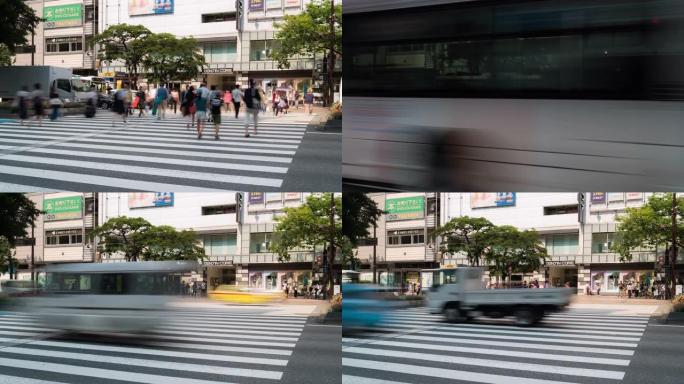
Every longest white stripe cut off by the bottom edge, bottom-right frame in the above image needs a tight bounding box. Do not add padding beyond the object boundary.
[342,357,575,384]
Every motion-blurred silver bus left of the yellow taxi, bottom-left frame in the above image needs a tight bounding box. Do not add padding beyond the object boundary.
[22,261,201,332]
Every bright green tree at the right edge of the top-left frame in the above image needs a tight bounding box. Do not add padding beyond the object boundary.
[271,0,342,105]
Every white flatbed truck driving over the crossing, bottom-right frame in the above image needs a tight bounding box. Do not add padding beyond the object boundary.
[427,267,572,326]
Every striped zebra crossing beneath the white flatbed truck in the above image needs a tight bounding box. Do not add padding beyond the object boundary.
[342,308,649,384]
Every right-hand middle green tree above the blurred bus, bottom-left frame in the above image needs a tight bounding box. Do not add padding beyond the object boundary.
[141,225,206,261]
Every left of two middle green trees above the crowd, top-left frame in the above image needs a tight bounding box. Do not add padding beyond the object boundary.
[93,24,152,89]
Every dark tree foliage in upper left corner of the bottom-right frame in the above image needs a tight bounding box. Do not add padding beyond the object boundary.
[342,191,385,247]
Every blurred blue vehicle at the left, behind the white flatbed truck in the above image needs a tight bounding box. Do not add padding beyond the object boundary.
[342,283,402,330]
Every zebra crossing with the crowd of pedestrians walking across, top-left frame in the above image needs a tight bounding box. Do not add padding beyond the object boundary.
[0,111,307,191]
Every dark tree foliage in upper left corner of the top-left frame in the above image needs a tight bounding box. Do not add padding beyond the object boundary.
[0,0,42,53]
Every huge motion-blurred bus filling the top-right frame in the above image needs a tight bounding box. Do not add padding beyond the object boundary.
[342,0,684,191]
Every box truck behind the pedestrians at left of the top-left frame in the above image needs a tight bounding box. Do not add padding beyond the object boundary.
[0,66,80,101]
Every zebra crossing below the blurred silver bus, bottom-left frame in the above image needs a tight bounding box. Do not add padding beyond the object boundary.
[0,309,307,384]
